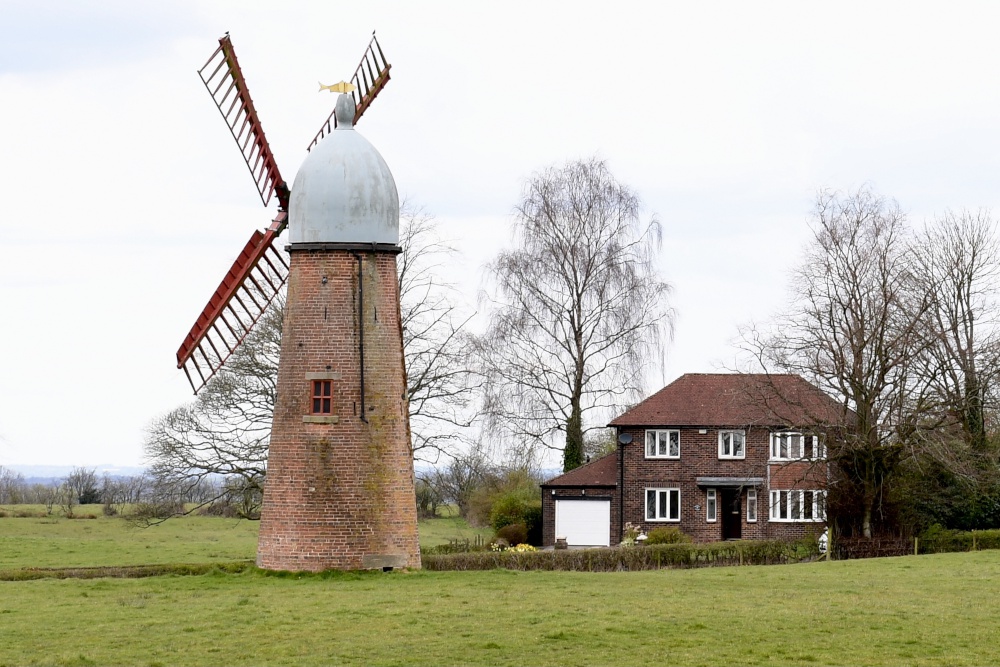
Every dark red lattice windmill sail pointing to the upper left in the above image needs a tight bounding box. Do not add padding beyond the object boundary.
[198,34,288,211]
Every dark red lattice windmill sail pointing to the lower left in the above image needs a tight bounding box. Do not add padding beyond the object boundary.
[177,213,288,393]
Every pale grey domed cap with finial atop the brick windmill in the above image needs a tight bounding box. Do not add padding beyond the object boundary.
[288,94,399,245]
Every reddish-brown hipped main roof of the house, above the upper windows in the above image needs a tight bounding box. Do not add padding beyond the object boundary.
[610,373,849,426]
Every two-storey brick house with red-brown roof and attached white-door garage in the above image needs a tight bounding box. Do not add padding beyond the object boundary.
[541,373,846,546]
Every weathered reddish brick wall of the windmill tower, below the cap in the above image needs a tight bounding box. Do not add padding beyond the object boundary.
[257,248,420,571]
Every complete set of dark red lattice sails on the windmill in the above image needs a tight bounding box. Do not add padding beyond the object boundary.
[177,33,391,393]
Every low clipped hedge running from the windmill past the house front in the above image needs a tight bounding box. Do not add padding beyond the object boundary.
[422,540,819,572]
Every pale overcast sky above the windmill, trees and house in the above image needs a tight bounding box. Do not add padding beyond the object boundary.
[0,0,1000,465]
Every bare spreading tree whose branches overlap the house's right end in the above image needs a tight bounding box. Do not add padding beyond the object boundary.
[743,188,930,537]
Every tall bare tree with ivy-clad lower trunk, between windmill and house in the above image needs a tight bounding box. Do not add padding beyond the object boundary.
[476,158,673,470]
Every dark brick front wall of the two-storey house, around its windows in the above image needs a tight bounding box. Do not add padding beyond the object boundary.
[620,427,826,542]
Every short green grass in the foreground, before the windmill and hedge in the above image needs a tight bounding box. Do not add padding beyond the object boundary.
[0,551,1000,665]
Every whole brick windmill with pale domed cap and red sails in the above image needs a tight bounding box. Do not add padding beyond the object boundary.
[178,36,420,571]
